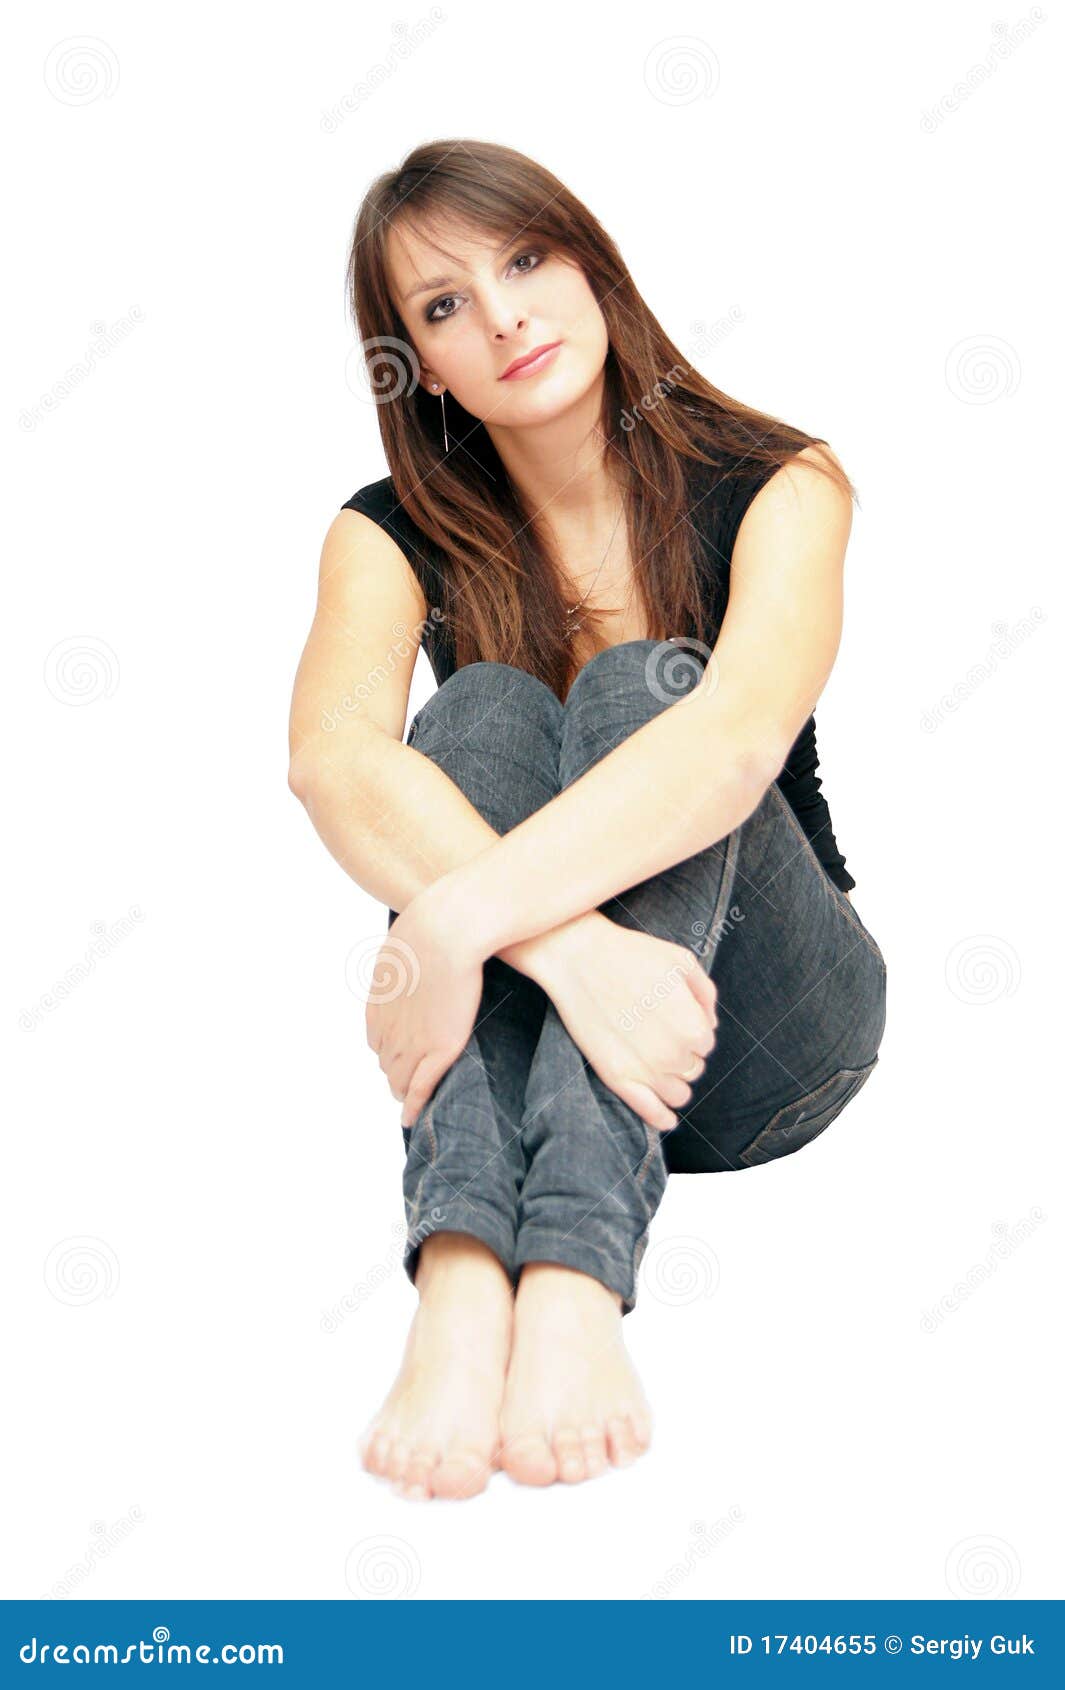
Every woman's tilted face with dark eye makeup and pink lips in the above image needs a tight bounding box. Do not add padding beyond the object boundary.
[387,225,609,428]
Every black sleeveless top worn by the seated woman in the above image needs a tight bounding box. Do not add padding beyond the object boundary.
[341,460,857,892]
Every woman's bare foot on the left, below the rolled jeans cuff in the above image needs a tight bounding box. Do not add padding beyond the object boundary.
[358,1232,514,1499]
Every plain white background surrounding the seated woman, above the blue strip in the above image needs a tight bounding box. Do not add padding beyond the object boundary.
[0,0,1062,1600]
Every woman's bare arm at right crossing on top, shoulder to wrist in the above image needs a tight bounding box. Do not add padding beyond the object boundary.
[419,448,850,962]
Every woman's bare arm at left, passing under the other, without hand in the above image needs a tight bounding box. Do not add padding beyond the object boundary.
[289,510,605,979]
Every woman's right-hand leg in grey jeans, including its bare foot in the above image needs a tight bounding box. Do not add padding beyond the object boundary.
[502,641,884,1484]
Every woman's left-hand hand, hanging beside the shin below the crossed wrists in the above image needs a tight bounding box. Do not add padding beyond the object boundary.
[367,887,483,1127]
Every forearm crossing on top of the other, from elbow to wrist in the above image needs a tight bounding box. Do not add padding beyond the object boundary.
[440,696,776,957]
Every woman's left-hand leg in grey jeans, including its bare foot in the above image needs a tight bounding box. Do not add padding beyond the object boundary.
[362,662,563,1497]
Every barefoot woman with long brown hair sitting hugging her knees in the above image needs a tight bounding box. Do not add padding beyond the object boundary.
[291,142,886,1497]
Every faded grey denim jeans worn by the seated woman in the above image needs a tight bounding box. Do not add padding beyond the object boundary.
[389,641,886,1313]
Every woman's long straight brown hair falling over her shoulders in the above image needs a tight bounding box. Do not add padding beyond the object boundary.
[347,140,855,696]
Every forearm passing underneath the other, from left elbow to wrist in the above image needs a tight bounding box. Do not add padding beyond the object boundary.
[289,728,604,979]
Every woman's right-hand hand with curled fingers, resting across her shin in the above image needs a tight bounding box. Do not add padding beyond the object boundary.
[527,911,717,1132]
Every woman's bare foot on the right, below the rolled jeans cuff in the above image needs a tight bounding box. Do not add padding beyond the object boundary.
[500,1262,651,1484]
